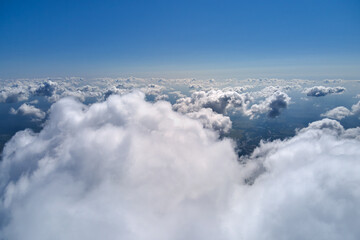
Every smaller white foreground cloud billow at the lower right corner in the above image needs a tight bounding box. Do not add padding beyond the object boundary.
[233,119,360,240]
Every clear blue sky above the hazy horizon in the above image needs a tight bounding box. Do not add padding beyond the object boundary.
[0,0,360,79]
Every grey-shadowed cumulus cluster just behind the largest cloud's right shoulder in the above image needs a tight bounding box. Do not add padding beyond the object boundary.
[173,86,291,129]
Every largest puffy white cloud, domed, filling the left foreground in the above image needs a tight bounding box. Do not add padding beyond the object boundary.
[0,93,238,240]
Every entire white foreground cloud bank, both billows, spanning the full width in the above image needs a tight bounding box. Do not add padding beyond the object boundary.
[0,92,360,240]
